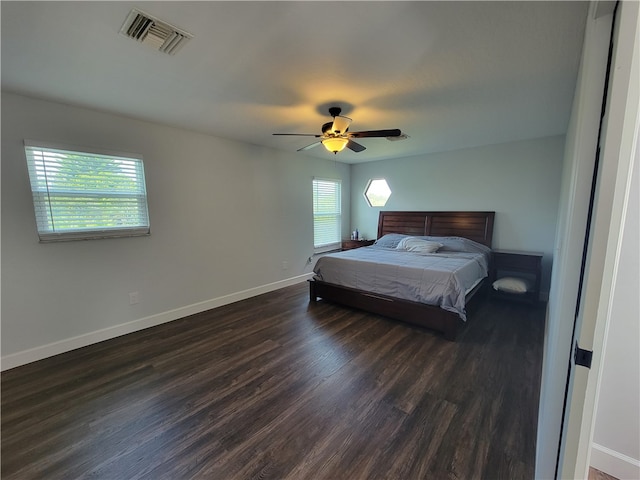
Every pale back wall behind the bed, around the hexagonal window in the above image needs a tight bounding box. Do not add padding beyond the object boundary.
[351,136,564,293]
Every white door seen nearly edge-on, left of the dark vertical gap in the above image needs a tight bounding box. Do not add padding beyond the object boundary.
[535,2,613,480]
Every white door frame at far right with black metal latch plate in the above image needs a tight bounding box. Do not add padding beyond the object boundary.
[558,2,640,479]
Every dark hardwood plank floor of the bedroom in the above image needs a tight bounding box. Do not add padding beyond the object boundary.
[1,283,544,480]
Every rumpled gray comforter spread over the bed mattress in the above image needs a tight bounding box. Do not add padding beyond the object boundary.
[314,245,488,320]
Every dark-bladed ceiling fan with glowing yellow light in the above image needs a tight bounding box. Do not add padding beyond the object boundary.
[274,107,402,154]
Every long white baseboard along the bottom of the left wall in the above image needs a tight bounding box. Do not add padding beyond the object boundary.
[0,273,313,371]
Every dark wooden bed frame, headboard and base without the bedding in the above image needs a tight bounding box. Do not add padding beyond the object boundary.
[309,212,495,341]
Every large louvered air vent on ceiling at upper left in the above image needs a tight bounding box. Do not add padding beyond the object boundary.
[120,8,193,55]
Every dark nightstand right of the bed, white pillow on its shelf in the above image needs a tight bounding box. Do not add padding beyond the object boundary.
[489,250,544,304]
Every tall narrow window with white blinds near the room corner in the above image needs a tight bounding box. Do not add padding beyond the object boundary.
[313,178,342,253]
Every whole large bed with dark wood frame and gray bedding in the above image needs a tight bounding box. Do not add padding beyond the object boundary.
[309,211,495,340]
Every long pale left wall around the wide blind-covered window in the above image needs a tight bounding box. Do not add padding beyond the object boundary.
[1,93,350,369]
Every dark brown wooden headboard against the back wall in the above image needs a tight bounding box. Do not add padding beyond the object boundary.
[378,212,495,247]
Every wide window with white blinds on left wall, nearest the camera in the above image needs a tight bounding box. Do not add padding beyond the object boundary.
[25,141,150,242]
